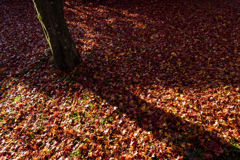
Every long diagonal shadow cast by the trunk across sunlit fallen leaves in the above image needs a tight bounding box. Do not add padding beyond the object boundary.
[67,47,239,158]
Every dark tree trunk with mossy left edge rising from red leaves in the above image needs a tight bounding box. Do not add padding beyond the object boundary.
[33,0,81,70]
